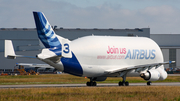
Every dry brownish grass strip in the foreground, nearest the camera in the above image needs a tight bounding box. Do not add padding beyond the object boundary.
[0,86,180,101]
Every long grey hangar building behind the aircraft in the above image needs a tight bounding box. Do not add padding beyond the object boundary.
[0,28,180,71]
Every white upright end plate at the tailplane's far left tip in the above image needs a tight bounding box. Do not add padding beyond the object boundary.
[4,40,16,59]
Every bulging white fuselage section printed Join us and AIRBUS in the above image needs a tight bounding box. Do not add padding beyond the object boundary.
[51,36,164,77]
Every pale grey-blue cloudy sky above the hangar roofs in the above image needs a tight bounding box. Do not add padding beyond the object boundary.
[0,0,180,34]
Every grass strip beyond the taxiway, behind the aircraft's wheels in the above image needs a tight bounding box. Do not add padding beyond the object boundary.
[0,74,180,85]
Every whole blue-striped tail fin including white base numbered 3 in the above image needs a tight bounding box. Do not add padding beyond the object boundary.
[33,12,72,59]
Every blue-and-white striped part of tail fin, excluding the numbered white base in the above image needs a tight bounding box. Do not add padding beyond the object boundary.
[33,12,62,49]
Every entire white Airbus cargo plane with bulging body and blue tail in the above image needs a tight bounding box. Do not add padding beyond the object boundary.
[5,12,175,86]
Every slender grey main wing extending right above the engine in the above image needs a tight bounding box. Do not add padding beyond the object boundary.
[105,61,175,76]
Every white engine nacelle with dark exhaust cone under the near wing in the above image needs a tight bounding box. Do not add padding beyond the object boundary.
[140,70,160,81]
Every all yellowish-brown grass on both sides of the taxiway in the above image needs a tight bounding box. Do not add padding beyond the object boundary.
[0,74,180,101]
